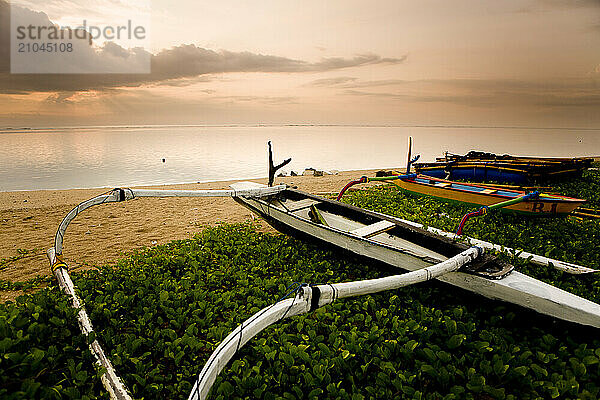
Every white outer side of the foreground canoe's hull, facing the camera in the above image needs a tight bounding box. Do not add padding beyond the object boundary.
[236,184,600,328]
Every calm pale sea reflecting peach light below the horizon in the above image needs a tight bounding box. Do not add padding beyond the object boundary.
[0,125,600,191]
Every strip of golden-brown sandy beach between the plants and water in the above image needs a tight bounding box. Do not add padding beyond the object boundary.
[0,167,384,301]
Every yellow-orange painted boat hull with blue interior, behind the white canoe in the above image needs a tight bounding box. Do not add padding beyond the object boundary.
[390,174,585,216]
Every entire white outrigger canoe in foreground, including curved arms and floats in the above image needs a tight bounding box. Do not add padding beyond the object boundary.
[48,145,600,400]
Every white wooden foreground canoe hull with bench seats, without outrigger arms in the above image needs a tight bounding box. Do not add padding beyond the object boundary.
[231,182,600,328]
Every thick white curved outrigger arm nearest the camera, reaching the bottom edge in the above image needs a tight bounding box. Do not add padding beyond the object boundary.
[188,246,484,400]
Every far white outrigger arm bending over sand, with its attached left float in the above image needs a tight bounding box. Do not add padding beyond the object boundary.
[47,185,286,400]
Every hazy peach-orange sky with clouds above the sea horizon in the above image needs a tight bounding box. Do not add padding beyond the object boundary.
[0,0,600,128]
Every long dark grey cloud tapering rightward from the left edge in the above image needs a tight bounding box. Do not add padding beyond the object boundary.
[0,0,406,93]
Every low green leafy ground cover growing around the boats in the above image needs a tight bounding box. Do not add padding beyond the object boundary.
[0,171,600,399]
